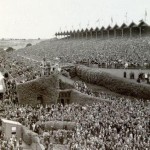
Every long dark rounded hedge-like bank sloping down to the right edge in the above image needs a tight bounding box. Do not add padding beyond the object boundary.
[76,65,150,99]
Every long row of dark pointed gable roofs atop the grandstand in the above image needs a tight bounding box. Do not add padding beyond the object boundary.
[55,20,150,39]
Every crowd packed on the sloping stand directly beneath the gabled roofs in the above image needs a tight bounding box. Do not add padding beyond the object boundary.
[14,37,150,68]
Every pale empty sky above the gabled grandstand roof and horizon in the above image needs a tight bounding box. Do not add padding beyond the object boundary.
[0,0,150,39]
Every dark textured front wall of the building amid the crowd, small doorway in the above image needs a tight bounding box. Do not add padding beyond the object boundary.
[17,75,59,105]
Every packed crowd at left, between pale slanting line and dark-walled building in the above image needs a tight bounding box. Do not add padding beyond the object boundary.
[1,57,41,83]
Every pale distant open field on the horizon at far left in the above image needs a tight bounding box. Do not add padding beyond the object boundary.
[0,39,42,50]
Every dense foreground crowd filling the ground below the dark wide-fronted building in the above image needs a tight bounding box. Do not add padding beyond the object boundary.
[0,98,150,150]
